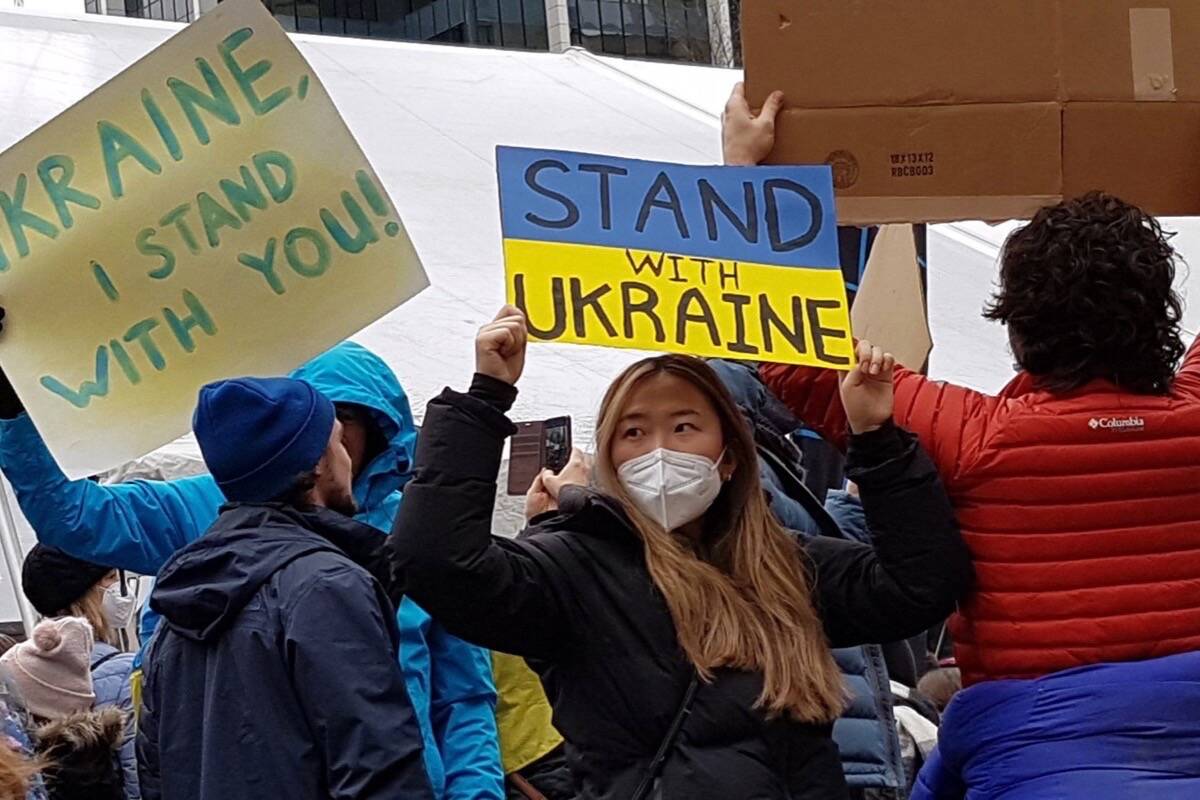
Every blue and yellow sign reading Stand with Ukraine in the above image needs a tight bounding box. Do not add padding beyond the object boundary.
[497,148,853,369]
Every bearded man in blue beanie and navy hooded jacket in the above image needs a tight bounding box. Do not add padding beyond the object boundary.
[138,378,433,800]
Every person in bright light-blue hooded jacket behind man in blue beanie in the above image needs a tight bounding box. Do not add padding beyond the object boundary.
[0,343,504,800]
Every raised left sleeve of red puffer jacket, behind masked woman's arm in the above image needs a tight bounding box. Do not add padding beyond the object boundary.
[761,363,1003,483]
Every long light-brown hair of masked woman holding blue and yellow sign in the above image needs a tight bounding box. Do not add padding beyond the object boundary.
[596,355,846,722]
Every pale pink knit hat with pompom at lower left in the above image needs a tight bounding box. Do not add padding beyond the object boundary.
[0,616,96,720]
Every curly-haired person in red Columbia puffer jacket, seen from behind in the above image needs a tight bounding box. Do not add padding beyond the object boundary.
[725,82,1200,685]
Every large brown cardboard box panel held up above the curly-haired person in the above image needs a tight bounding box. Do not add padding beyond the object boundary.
[742,0,1200,224]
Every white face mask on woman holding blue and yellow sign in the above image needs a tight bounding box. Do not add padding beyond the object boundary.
[617,447,724,530]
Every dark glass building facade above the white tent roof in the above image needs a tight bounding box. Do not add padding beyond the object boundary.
[85,0,713,64]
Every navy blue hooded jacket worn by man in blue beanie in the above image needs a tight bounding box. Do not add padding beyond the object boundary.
[138,504,433,800]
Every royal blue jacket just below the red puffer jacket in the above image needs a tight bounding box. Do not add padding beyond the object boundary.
[912,652,1200,800]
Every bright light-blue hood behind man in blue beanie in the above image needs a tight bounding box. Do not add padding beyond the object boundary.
[292,342,416,531]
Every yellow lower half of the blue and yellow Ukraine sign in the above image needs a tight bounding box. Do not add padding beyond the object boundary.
[504,239,853,369]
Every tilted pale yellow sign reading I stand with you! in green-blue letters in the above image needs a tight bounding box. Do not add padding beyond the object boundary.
[0,0,427,477]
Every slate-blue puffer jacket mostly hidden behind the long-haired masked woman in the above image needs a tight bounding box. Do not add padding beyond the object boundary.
[709,361,906,789]
